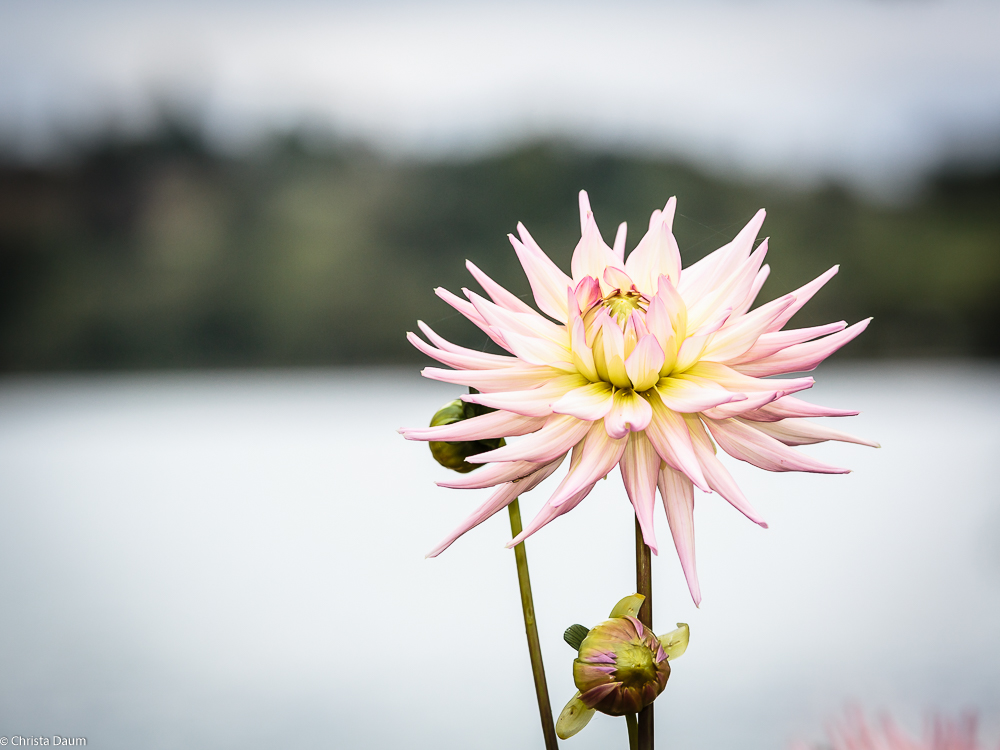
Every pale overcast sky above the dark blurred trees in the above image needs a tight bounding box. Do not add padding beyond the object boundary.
[0,0,1000,191]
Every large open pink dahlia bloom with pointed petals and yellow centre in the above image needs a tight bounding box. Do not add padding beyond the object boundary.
[401,192,876,603]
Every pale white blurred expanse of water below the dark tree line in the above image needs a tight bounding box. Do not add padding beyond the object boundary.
[0,362,1000,750]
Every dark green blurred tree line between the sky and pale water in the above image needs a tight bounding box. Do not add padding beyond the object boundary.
[0,126,1000,372]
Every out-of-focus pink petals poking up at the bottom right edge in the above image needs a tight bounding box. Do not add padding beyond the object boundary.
[795,711,984,750]
